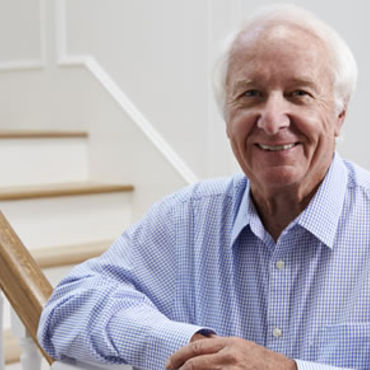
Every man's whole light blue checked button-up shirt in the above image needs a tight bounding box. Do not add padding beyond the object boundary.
[39,155,370,370]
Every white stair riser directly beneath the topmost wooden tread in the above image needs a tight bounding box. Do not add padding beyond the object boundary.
[0,138,88,187]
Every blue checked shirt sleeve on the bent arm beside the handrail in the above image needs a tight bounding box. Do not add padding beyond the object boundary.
[38,195,212,369]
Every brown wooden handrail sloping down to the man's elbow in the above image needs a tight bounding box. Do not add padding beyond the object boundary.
[0,211,54,364]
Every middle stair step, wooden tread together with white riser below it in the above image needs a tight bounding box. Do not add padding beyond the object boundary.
[0,183,133,250]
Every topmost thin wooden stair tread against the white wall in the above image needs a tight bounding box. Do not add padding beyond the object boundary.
[0,130,88,139]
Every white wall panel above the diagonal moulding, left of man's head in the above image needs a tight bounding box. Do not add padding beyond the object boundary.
[60,0,235,177]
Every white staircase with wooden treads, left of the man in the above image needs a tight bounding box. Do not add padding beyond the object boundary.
[0,130,134,363]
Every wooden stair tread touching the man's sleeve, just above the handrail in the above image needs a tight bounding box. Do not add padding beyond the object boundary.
[31,240,113,268]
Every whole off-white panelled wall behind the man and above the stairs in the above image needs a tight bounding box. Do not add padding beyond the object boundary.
[0,0,370,202]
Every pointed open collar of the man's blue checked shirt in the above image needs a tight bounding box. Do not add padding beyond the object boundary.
[231,153,348,248]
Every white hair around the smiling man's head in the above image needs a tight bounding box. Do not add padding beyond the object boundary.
[213,4,358,117]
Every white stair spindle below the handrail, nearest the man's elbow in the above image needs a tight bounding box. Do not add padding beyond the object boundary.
[11,310,41,370]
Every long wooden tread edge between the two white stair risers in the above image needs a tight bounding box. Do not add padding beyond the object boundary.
[0,182,134,201]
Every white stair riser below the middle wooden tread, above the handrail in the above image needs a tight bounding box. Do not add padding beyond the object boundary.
[0,193,132,250]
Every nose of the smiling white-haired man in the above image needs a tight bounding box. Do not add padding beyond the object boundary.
[257,92,290,135]
